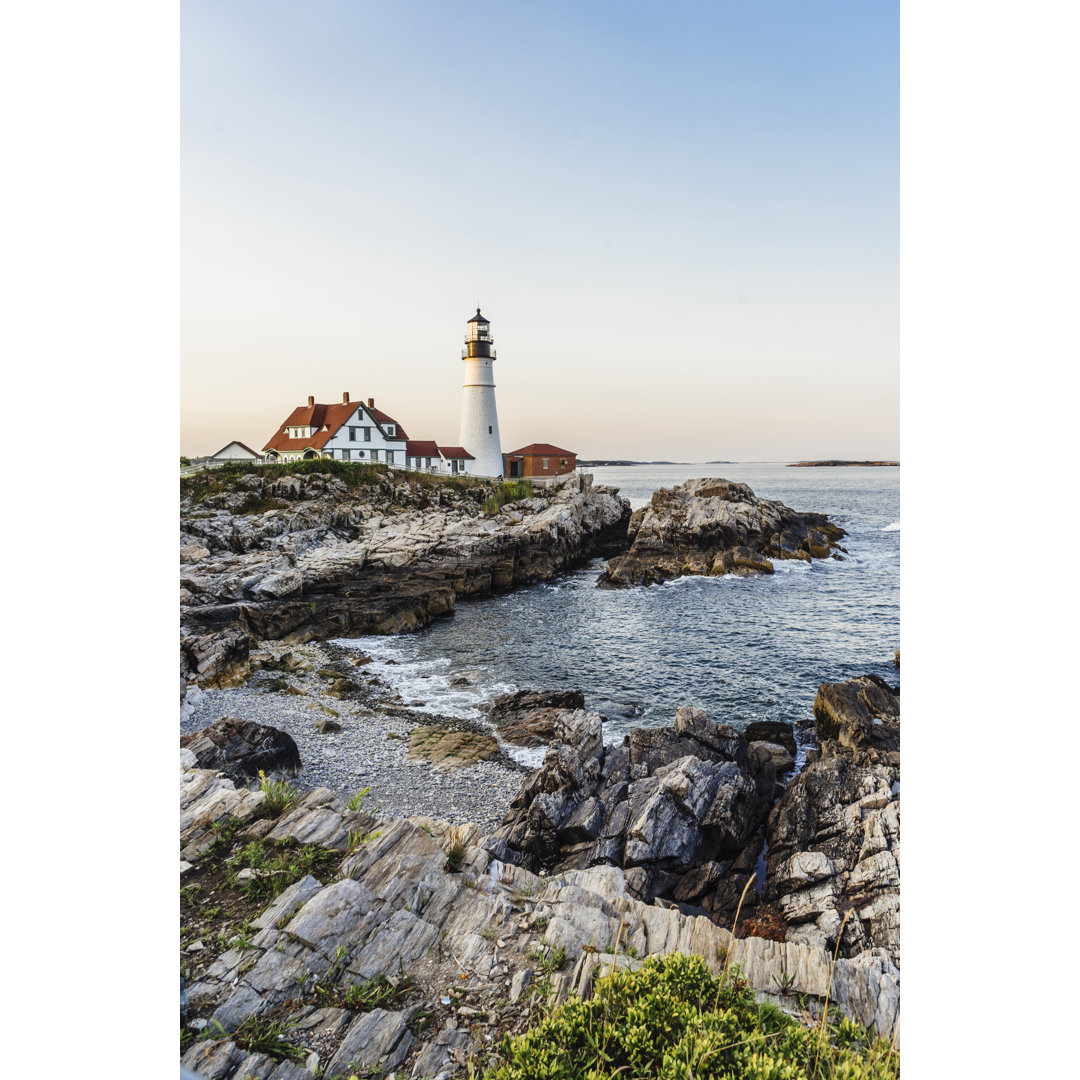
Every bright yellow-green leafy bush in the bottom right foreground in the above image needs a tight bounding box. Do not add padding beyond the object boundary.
[484,955,900,1080]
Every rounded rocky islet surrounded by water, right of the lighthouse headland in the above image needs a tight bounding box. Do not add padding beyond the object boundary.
[599,480,843,588]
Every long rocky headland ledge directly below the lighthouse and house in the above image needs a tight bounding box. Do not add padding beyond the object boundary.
[180,474,630,685]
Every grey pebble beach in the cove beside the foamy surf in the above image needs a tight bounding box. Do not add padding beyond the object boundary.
[180,643,527,829]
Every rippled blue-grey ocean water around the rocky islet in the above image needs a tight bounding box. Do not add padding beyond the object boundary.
[337,462,900,765]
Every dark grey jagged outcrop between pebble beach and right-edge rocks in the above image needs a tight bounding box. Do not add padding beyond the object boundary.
[486,707,775,915]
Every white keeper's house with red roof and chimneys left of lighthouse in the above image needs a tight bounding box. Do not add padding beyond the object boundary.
[262,392,474,475]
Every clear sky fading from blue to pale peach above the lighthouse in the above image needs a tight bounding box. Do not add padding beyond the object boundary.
[179,0,900,461]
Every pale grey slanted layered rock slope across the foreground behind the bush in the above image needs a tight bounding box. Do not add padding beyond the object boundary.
[180,752,899,1080]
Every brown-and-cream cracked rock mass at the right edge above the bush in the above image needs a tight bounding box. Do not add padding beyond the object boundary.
[765,675,900,964]
